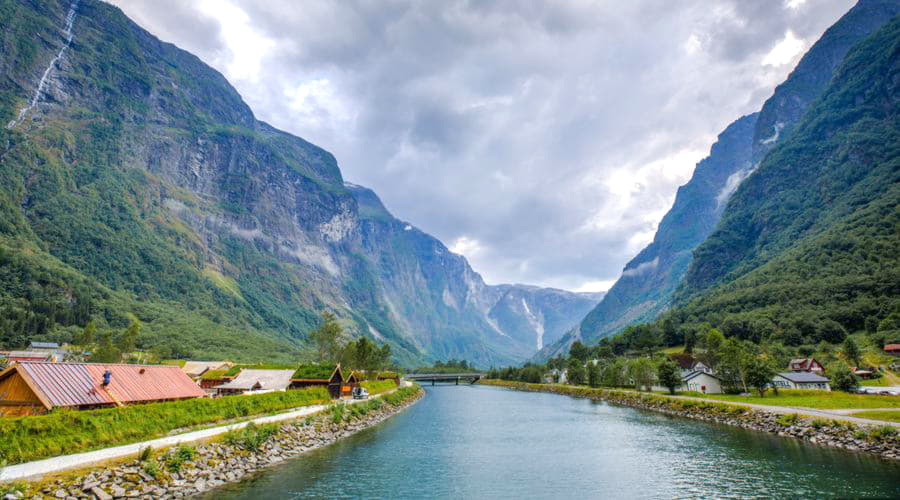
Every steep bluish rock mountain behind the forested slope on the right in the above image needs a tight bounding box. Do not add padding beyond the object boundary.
[537,0,900,360]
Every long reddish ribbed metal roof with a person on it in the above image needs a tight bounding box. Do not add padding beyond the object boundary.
[0,362,206,409]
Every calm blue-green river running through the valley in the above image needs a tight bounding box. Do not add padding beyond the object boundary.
[208,386,900,500]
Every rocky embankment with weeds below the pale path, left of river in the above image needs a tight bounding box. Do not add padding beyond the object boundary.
[0,386,424,500]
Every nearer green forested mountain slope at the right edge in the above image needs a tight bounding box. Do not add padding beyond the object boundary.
[676,16,900,336]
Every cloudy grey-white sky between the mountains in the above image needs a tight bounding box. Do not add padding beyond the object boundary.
[114,0,853,290]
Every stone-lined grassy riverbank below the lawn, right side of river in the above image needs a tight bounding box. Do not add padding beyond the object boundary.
[479,380,900,460]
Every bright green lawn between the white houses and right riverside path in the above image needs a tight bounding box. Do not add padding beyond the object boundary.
[678,389,900,410]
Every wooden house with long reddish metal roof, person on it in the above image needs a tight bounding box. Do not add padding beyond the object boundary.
[0,362,205,416]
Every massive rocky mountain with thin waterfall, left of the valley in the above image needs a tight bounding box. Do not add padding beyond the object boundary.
[0,0,596,365]
